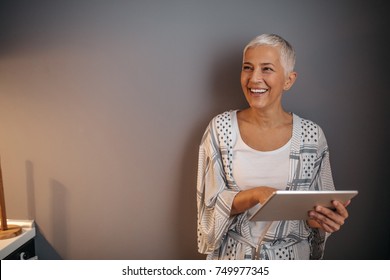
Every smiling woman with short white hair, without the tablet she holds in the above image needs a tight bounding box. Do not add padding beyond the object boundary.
[197,34,349,259]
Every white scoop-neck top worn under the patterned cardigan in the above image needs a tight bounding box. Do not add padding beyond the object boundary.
[232,111,291,242]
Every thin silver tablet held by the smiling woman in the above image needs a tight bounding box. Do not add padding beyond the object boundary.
[249,190,358,221]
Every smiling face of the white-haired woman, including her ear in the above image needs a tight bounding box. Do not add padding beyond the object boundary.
[241,45,296,109]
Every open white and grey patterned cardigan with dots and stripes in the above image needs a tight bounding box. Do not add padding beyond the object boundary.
[197,111,334,259]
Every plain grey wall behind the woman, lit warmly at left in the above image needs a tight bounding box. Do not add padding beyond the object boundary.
[0,0,390,259]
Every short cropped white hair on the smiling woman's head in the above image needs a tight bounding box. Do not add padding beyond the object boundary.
[243,34,295,76]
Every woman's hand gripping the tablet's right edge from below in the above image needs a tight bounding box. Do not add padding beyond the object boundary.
[308,200,351,233]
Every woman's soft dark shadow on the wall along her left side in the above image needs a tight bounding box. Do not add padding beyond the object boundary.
[176,45,247,259]
